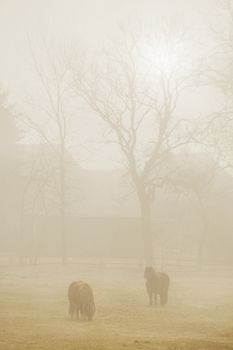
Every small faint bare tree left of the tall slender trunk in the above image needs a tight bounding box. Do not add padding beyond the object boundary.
[18,144,59,263]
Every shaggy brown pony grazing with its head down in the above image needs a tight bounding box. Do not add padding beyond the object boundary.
[68,281,95,321]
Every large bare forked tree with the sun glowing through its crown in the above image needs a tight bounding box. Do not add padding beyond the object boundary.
[73,25,196,265]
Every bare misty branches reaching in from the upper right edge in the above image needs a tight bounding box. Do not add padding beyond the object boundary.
[198,0,233,170]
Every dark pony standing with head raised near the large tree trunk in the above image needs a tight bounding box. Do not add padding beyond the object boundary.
[144,266,170,305]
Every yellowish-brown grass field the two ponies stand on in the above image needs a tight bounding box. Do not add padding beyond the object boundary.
[0,264,233,350]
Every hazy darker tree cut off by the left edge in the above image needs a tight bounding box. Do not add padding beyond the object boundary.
[0,88,21,262]
